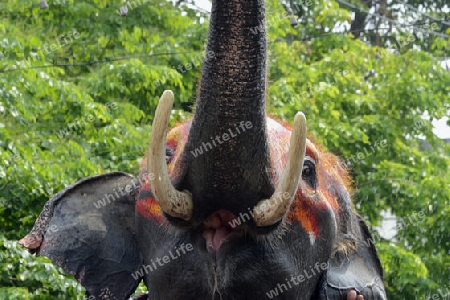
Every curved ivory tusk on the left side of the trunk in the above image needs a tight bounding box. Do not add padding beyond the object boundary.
[147,90,193,221]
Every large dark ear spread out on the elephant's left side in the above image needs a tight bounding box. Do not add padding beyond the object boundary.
[19,172,143,299]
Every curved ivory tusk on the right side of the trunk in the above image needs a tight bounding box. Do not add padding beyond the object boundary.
[253,112,306,226]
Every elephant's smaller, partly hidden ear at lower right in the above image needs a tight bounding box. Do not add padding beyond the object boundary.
[319,213,387,300]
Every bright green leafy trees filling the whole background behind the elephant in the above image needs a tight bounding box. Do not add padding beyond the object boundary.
[0,0,450,299]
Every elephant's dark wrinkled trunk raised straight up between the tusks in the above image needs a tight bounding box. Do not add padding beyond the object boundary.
[179,0,274,218]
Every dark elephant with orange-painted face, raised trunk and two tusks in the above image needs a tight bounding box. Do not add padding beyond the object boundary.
[19,0,387,300]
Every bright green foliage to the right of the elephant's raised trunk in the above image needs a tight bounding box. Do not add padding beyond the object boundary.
[268,2,450,299]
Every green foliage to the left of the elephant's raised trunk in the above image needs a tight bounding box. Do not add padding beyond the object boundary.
[0,1,206,299]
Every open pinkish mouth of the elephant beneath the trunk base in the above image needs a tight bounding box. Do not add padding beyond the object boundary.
[203,209,244,252]
